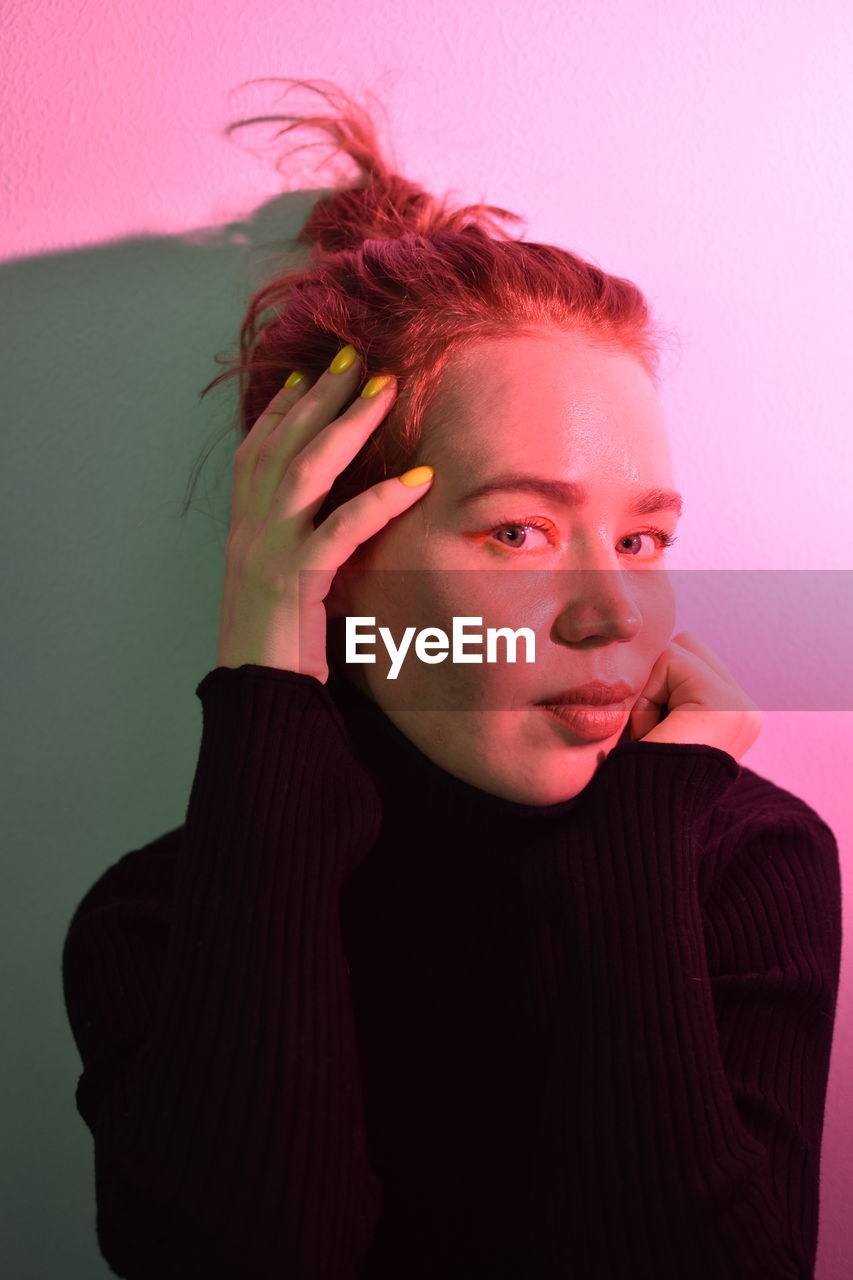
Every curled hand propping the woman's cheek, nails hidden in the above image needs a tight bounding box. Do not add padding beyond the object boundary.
[626,631,763,760]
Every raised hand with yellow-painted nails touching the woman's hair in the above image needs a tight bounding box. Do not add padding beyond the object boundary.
[216,347,432,684]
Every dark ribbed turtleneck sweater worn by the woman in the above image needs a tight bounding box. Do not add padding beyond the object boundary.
[63,666,841,1280]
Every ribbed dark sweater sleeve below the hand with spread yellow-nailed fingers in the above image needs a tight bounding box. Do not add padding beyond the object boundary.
[63,664,380,1280]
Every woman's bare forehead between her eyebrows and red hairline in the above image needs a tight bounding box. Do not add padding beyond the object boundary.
[423,332,670,484]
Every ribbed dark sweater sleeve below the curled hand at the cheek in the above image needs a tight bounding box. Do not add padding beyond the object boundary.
[522,742,841,1280]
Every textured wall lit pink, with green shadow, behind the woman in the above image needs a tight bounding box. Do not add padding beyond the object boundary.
[0,0,853,1280]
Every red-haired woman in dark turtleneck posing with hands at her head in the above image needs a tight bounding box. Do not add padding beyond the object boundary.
[64,80,840,1280]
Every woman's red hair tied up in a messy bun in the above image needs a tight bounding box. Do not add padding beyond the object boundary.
[178,81,669,526]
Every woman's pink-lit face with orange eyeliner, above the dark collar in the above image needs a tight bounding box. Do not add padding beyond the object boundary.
[328,330,678,805]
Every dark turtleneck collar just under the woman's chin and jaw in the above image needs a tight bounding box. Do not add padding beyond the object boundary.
[327,662,614,832]
